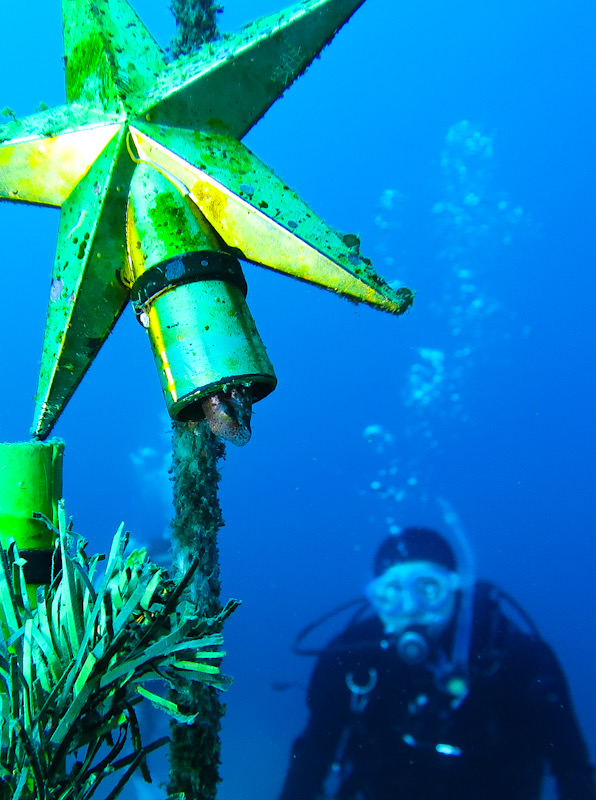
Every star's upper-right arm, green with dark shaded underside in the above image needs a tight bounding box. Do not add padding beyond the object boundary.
[139,0,364,139]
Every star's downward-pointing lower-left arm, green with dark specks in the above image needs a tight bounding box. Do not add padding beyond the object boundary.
[35,126,134,438]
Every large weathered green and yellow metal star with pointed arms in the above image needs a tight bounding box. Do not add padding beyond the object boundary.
[0,0,412,438]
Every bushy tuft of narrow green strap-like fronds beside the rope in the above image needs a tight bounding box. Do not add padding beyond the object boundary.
[0,507,237,800]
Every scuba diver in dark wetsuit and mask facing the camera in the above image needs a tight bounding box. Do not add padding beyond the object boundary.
[279,528,596,800]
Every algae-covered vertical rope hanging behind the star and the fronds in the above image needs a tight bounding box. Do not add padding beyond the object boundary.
[168,7,225,800]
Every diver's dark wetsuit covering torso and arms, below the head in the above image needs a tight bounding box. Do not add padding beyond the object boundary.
[280,589,596,800]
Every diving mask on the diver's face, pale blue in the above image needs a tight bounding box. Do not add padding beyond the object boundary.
[366,561,460,633]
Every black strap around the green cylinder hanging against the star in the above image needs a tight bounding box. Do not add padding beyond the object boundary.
[130,250,247,314]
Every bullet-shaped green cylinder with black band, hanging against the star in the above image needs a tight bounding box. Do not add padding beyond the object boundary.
[127,164,276,421]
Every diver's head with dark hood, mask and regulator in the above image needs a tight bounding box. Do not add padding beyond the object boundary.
[367,528,460,644]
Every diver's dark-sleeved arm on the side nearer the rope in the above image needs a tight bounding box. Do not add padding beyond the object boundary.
[279,654,348,800]
